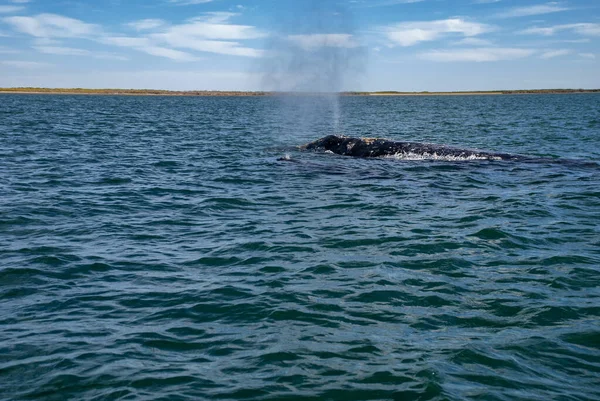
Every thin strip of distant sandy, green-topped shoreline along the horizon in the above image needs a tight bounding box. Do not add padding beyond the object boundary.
[0,88,600,97]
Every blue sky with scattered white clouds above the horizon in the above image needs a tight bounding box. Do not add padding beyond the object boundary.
[0,0,600,91]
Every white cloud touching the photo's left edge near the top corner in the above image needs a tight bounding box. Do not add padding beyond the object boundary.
[3,14,99,38]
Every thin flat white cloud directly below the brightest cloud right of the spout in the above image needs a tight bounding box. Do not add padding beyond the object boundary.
[418,47,535,62]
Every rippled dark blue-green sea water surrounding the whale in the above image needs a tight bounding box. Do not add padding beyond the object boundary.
[0,95,600,400]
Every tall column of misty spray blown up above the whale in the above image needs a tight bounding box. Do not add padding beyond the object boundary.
[262,0,366,139]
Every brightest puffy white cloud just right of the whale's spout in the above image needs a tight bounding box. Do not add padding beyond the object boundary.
[384,18,495,46]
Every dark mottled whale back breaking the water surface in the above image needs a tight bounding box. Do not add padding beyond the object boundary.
[300,135,523,160]
